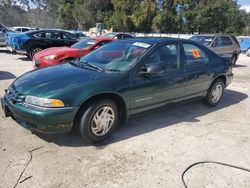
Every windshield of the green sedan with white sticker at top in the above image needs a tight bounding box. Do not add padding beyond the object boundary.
[78,40,151,72]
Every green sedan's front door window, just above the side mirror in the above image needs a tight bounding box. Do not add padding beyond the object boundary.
[145,44,179,70]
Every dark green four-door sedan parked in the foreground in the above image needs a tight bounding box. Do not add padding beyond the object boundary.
[1,38,233,142]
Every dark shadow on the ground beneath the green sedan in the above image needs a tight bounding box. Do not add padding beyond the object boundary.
[37,90,248,149]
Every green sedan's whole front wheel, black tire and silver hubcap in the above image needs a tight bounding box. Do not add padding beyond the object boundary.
[77,99,119,143]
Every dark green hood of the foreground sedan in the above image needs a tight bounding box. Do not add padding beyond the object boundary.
[12,63,112,97]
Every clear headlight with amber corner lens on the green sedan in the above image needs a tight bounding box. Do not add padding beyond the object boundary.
[24,96,64,108]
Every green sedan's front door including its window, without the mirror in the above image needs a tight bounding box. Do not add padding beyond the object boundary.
[130,43,185,114]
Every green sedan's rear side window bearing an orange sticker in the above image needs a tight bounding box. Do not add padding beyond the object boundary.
[183,44,209,66]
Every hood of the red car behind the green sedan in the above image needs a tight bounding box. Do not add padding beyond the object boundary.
[36,47,80,57]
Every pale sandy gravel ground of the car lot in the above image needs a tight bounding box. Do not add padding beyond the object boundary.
[0,49,250,188]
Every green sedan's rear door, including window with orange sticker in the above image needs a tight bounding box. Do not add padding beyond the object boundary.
[182,42,213,97]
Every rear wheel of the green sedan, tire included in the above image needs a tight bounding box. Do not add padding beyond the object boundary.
[205,79,225,106]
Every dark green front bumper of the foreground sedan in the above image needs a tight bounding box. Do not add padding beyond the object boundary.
[1,95,78,134]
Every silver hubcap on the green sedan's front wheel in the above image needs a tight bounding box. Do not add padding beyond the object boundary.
[91,106,115,136]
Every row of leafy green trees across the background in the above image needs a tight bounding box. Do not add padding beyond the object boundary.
[0,0,250,35]
